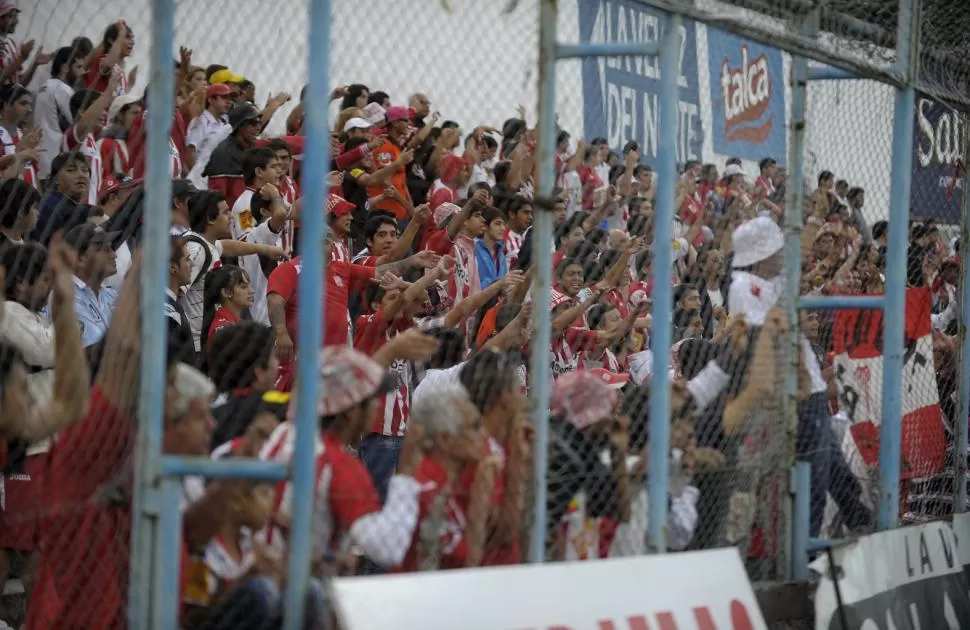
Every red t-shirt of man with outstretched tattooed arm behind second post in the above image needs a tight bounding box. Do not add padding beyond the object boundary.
[266,256,376,346]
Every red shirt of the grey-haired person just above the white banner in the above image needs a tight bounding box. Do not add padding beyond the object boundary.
[395,456,468,572]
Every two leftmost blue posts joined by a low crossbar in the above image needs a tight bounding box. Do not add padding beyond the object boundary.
[135,0,331,630]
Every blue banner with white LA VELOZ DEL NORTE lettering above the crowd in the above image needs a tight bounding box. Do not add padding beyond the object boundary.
[579,0,704,165]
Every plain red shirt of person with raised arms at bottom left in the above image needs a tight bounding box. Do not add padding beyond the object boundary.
[26,385,137,630]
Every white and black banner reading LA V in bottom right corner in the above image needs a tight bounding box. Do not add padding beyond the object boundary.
[812,522,970,630]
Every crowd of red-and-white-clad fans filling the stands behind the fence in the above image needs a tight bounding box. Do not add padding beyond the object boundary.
[0,6,959,629]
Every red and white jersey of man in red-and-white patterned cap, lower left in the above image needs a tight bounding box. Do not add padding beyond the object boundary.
[260,422,380,557]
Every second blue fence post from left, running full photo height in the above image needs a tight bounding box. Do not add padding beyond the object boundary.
[283,0,331,630]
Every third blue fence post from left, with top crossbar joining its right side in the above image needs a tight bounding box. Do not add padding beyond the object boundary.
[529,0,558,563]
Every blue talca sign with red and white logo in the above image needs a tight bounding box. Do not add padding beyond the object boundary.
[707,28,788,164]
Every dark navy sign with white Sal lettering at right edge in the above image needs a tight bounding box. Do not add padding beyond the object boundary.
[909,96,967,225]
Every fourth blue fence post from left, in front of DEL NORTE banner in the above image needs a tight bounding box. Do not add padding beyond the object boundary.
[647,14,683,553]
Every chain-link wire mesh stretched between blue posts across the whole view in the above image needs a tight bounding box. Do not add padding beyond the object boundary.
[0,0,967,628]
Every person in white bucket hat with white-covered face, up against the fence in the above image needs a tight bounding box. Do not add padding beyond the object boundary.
[687,217,871,536]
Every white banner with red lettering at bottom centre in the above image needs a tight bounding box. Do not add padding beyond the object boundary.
[332,549,764,630]
